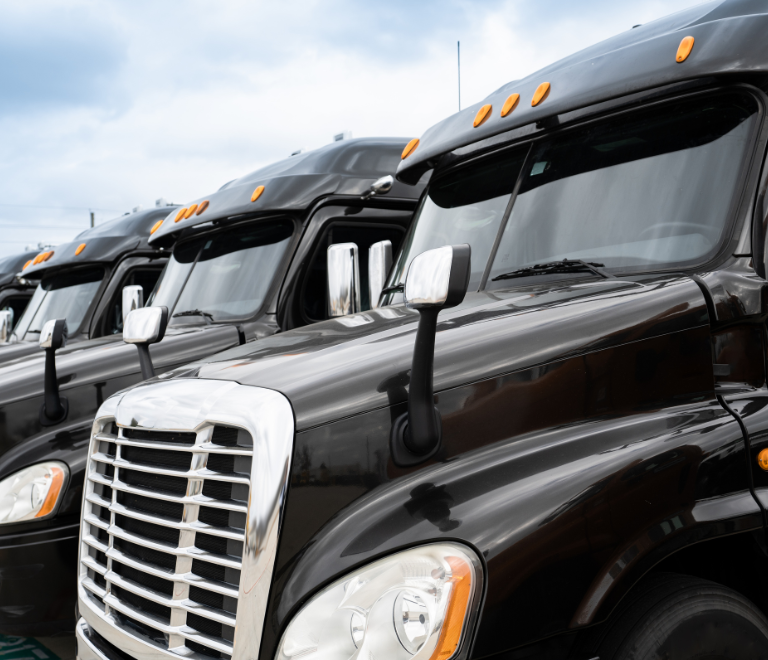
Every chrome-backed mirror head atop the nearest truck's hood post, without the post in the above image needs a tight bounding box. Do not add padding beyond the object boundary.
[404,245,470,309]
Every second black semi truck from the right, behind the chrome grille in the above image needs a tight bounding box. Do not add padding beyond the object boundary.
[0,138,423,636]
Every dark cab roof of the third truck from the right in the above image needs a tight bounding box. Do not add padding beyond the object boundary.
[19,206,177,279]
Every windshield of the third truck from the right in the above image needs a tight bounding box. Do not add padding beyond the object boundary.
[15,268,104,340]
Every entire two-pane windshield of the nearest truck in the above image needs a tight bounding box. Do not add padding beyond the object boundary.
[389,93,758,300]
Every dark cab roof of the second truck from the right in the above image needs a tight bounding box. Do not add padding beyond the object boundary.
[150,138,424,245]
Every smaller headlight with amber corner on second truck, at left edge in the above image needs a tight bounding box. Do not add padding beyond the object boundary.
[0,461,69,524]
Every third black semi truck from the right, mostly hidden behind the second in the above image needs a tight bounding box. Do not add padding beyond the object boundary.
[0,206,175,364]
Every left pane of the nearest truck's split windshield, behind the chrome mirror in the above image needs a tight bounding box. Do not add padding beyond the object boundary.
[390,152,528,291]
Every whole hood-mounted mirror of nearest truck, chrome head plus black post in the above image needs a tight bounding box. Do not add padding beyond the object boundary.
[390,245,472,467]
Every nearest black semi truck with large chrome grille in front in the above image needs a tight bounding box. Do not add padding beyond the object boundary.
[77,0,768,660]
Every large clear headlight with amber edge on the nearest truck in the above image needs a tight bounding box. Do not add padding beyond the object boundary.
[277,543,481,660]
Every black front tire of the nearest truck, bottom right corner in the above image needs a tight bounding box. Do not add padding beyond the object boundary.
[587,573,768,660]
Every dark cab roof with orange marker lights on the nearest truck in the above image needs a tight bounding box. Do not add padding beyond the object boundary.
[397,0,768,183]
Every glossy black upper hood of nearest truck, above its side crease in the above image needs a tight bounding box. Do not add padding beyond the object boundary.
[166,275,709,431]
